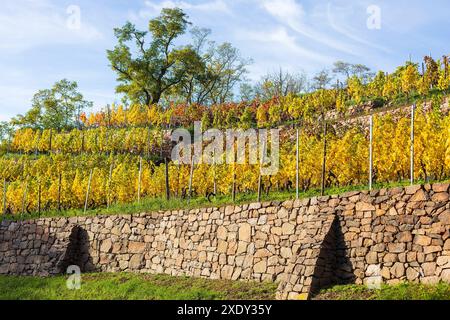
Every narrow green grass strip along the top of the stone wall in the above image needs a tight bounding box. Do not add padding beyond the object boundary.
[0,180,449,221]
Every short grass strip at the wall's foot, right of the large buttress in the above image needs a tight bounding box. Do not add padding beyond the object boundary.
[314,282,450,300]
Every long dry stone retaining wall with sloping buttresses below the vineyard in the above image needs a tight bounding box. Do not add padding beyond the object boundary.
[0,184,450,299]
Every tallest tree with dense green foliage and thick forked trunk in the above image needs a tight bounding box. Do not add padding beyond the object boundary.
[107,8,203,105]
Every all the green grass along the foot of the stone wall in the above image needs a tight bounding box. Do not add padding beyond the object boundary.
[0,273,450,300]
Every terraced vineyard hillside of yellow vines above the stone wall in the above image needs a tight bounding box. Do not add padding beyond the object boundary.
[0,57,450,215]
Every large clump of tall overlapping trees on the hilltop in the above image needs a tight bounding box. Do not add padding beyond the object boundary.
[107,8,249,106]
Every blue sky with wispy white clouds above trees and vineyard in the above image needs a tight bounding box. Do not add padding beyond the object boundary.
[0,0,450,121]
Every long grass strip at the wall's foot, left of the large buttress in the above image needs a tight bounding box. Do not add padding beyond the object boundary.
[0,273,277,300]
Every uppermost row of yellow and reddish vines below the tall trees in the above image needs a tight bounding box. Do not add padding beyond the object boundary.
[63,56,450,129]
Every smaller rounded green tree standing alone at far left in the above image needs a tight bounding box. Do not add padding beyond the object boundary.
[12,79,92,131]
